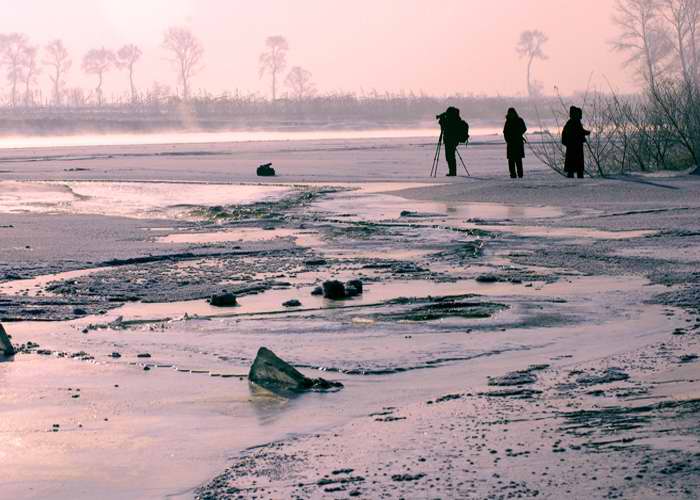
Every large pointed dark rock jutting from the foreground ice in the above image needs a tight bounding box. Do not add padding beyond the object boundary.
[248,347,343,392]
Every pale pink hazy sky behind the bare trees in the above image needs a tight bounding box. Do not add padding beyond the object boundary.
[0,0,635,99]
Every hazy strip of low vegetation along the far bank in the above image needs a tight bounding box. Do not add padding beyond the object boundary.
[0,94,582,135]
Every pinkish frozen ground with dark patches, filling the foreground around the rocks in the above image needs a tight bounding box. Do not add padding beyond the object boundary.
[0,139,700,498]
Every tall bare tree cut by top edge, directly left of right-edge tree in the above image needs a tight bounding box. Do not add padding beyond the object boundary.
[612,0,671,87]
